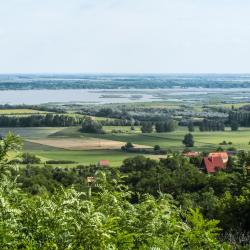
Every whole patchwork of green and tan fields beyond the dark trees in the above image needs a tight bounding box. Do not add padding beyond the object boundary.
[3,127,250,166]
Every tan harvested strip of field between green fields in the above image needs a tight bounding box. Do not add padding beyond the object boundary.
[27,138,151,150]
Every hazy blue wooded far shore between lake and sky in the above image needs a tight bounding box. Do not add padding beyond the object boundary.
[0,74,250,90]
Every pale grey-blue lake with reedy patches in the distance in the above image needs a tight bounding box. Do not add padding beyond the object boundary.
[0,88,250,105]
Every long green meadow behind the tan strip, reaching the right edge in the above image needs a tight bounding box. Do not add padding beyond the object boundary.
[50,126,250,151]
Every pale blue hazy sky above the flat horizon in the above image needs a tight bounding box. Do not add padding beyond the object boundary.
[0,0,250,73]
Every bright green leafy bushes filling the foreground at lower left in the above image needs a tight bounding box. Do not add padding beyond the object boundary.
[0,134,235,249]
